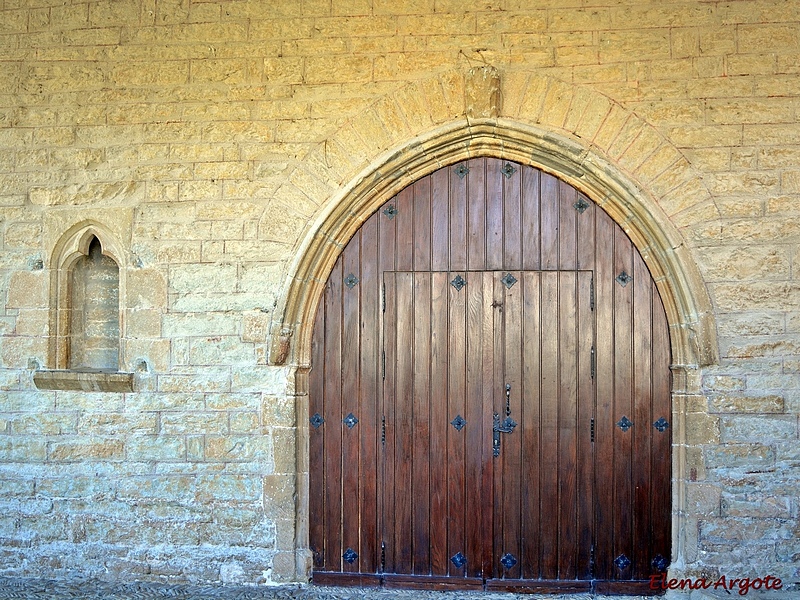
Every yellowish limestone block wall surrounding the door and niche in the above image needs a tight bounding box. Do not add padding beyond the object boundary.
[0,0,800,583]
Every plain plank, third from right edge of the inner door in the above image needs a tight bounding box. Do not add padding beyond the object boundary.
[539,272,562,579]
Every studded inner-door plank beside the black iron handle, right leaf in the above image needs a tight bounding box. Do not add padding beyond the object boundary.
[494,271,526,579]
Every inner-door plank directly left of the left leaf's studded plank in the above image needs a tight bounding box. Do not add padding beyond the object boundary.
[430,272,450,576]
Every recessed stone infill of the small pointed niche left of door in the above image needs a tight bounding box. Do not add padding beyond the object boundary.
[67,236,119,371]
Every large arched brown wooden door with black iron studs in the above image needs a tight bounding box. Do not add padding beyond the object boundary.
[309,158,671,593]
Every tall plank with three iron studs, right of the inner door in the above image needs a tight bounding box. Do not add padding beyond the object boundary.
[612,228,636,579]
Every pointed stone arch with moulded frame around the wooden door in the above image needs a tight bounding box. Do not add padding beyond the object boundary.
[271,68,719,577]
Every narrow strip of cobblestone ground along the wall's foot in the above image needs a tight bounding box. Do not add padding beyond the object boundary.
[0,578,660,600]
